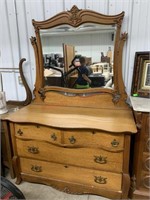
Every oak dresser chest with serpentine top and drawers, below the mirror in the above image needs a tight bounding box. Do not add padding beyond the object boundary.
[6,94,136,199]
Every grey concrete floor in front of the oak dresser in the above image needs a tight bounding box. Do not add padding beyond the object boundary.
[6,172,108,200]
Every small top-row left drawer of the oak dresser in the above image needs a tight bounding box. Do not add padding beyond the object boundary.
[15,124,61,144]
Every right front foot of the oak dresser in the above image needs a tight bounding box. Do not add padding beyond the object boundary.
[122,174,130,199]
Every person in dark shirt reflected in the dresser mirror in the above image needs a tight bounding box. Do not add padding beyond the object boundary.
[73,56,91,89]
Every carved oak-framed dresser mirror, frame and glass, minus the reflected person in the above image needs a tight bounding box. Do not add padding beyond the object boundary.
[31,6,127,102]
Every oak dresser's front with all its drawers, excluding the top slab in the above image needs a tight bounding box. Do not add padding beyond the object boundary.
[11,116,135,199]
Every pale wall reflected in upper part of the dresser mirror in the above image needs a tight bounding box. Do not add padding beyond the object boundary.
[42,32,114,63]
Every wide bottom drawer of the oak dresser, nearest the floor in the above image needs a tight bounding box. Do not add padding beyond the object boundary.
[20,158,122,191]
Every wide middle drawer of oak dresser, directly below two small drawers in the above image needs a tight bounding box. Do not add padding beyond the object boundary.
[16,139,123,172]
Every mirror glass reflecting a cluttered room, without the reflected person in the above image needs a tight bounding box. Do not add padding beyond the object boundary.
[40,23,116,88]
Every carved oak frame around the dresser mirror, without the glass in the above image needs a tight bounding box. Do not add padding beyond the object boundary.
[31,5,127,103]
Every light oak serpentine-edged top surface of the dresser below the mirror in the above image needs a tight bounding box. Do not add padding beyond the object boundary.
[7,104,137,133]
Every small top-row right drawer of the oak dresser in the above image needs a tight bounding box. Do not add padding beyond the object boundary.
[63,130,124,151]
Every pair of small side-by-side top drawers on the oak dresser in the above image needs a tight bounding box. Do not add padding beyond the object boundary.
[15,124,124,151]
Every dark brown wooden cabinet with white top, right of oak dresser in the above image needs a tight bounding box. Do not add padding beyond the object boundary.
[131,97,150,199]
